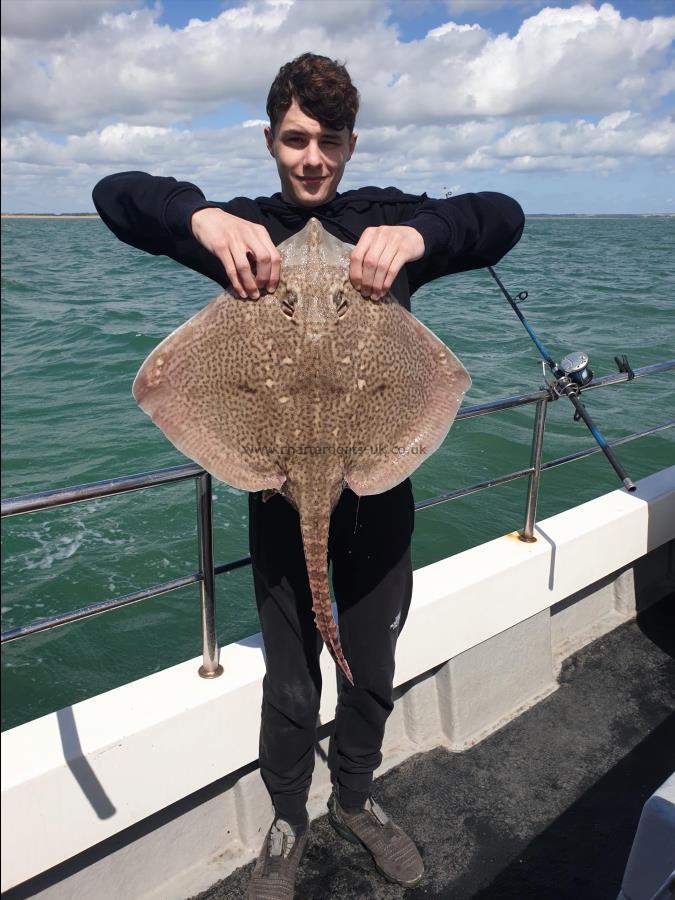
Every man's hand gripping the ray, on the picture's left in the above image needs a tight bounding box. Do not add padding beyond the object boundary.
[190,207,281,300]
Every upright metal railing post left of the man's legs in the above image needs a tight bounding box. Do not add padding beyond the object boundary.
[197,472,223,678]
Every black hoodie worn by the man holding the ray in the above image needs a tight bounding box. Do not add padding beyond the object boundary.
[93,172,525,308]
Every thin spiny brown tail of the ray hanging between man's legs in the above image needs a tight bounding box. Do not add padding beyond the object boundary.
[300,512,354,684]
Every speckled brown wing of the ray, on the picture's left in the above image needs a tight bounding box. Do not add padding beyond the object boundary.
[132,291,284,491]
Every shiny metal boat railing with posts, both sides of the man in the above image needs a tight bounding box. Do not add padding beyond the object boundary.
[1,359,675,678]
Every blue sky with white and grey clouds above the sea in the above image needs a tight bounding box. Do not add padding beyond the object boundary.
[2,0,675,214]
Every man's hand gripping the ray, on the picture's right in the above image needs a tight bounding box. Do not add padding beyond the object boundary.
[349,225,424,300]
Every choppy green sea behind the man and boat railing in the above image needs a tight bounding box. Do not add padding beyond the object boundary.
[2,217,675,728]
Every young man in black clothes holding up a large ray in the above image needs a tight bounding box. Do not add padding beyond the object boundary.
[94,53,524,900]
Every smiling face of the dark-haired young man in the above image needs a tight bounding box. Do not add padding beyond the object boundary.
[265,100,356,206]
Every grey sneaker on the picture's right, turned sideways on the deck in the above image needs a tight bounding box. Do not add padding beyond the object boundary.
[328,791,424,887]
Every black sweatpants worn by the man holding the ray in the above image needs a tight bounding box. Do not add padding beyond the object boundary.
[249,479,414,825]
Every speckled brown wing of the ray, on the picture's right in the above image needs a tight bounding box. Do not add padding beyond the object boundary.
[346,301,471,495]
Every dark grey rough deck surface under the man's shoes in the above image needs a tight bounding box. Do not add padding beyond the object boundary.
[191,597,675,900]
